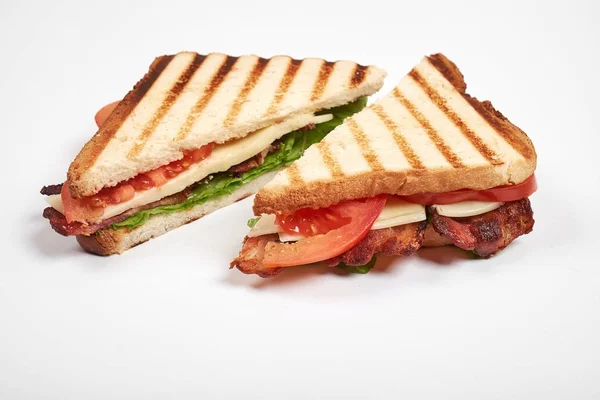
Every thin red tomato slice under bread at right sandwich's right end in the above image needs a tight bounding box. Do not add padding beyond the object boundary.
[399,175,537,206]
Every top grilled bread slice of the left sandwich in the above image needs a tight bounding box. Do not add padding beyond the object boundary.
[68,52,385,198]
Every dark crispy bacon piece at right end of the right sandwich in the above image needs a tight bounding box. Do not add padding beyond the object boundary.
[432,198,535,258]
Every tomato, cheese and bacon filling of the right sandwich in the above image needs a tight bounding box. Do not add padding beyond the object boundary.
[231,176,537,277]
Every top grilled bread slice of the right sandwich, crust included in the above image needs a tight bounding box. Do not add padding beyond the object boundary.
[254,54,536,215]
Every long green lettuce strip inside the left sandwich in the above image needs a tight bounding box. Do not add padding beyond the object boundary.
[110,97,367,230]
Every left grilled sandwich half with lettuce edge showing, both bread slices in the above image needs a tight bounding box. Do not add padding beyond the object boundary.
[41,52,385,255]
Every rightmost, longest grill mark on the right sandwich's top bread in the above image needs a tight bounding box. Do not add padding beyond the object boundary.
[408,69,503,165]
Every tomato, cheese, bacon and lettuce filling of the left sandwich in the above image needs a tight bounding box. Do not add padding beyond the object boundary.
[42,97,367,235]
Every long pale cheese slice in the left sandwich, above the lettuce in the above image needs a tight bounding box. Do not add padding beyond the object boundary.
[47,114,333,220]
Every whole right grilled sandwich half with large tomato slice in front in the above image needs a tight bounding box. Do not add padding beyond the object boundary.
[231,54,537,277]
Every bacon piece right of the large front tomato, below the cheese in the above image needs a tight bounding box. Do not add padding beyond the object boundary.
[325,221,427,267]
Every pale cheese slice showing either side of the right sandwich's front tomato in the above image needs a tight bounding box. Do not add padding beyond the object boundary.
[248,196,427,242]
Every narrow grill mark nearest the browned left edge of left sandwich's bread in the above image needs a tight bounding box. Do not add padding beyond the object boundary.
[127,54,206,158]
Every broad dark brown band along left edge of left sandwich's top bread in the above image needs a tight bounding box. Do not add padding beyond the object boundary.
[69,56,174,180]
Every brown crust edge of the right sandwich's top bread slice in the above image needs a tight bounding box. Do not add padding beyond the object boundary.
[253,54,537,215]
